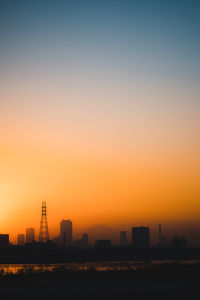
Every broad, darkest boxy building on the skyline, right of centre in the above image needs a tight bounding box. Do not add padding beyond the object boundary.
[132,226,150,249]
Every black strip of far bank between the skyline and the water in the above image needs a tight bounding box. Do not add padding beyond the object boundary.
[0,244,200,264]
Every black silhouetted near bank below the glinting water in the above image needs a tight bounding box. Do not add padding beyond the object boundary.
[0,263,200,300]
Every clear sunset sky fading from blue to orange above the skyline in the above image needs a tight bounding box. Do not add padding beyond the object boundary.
[0,0,200,244]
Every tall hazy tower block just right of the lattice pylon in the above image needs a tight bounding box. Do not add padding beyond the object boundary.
[60,220,72,248]
